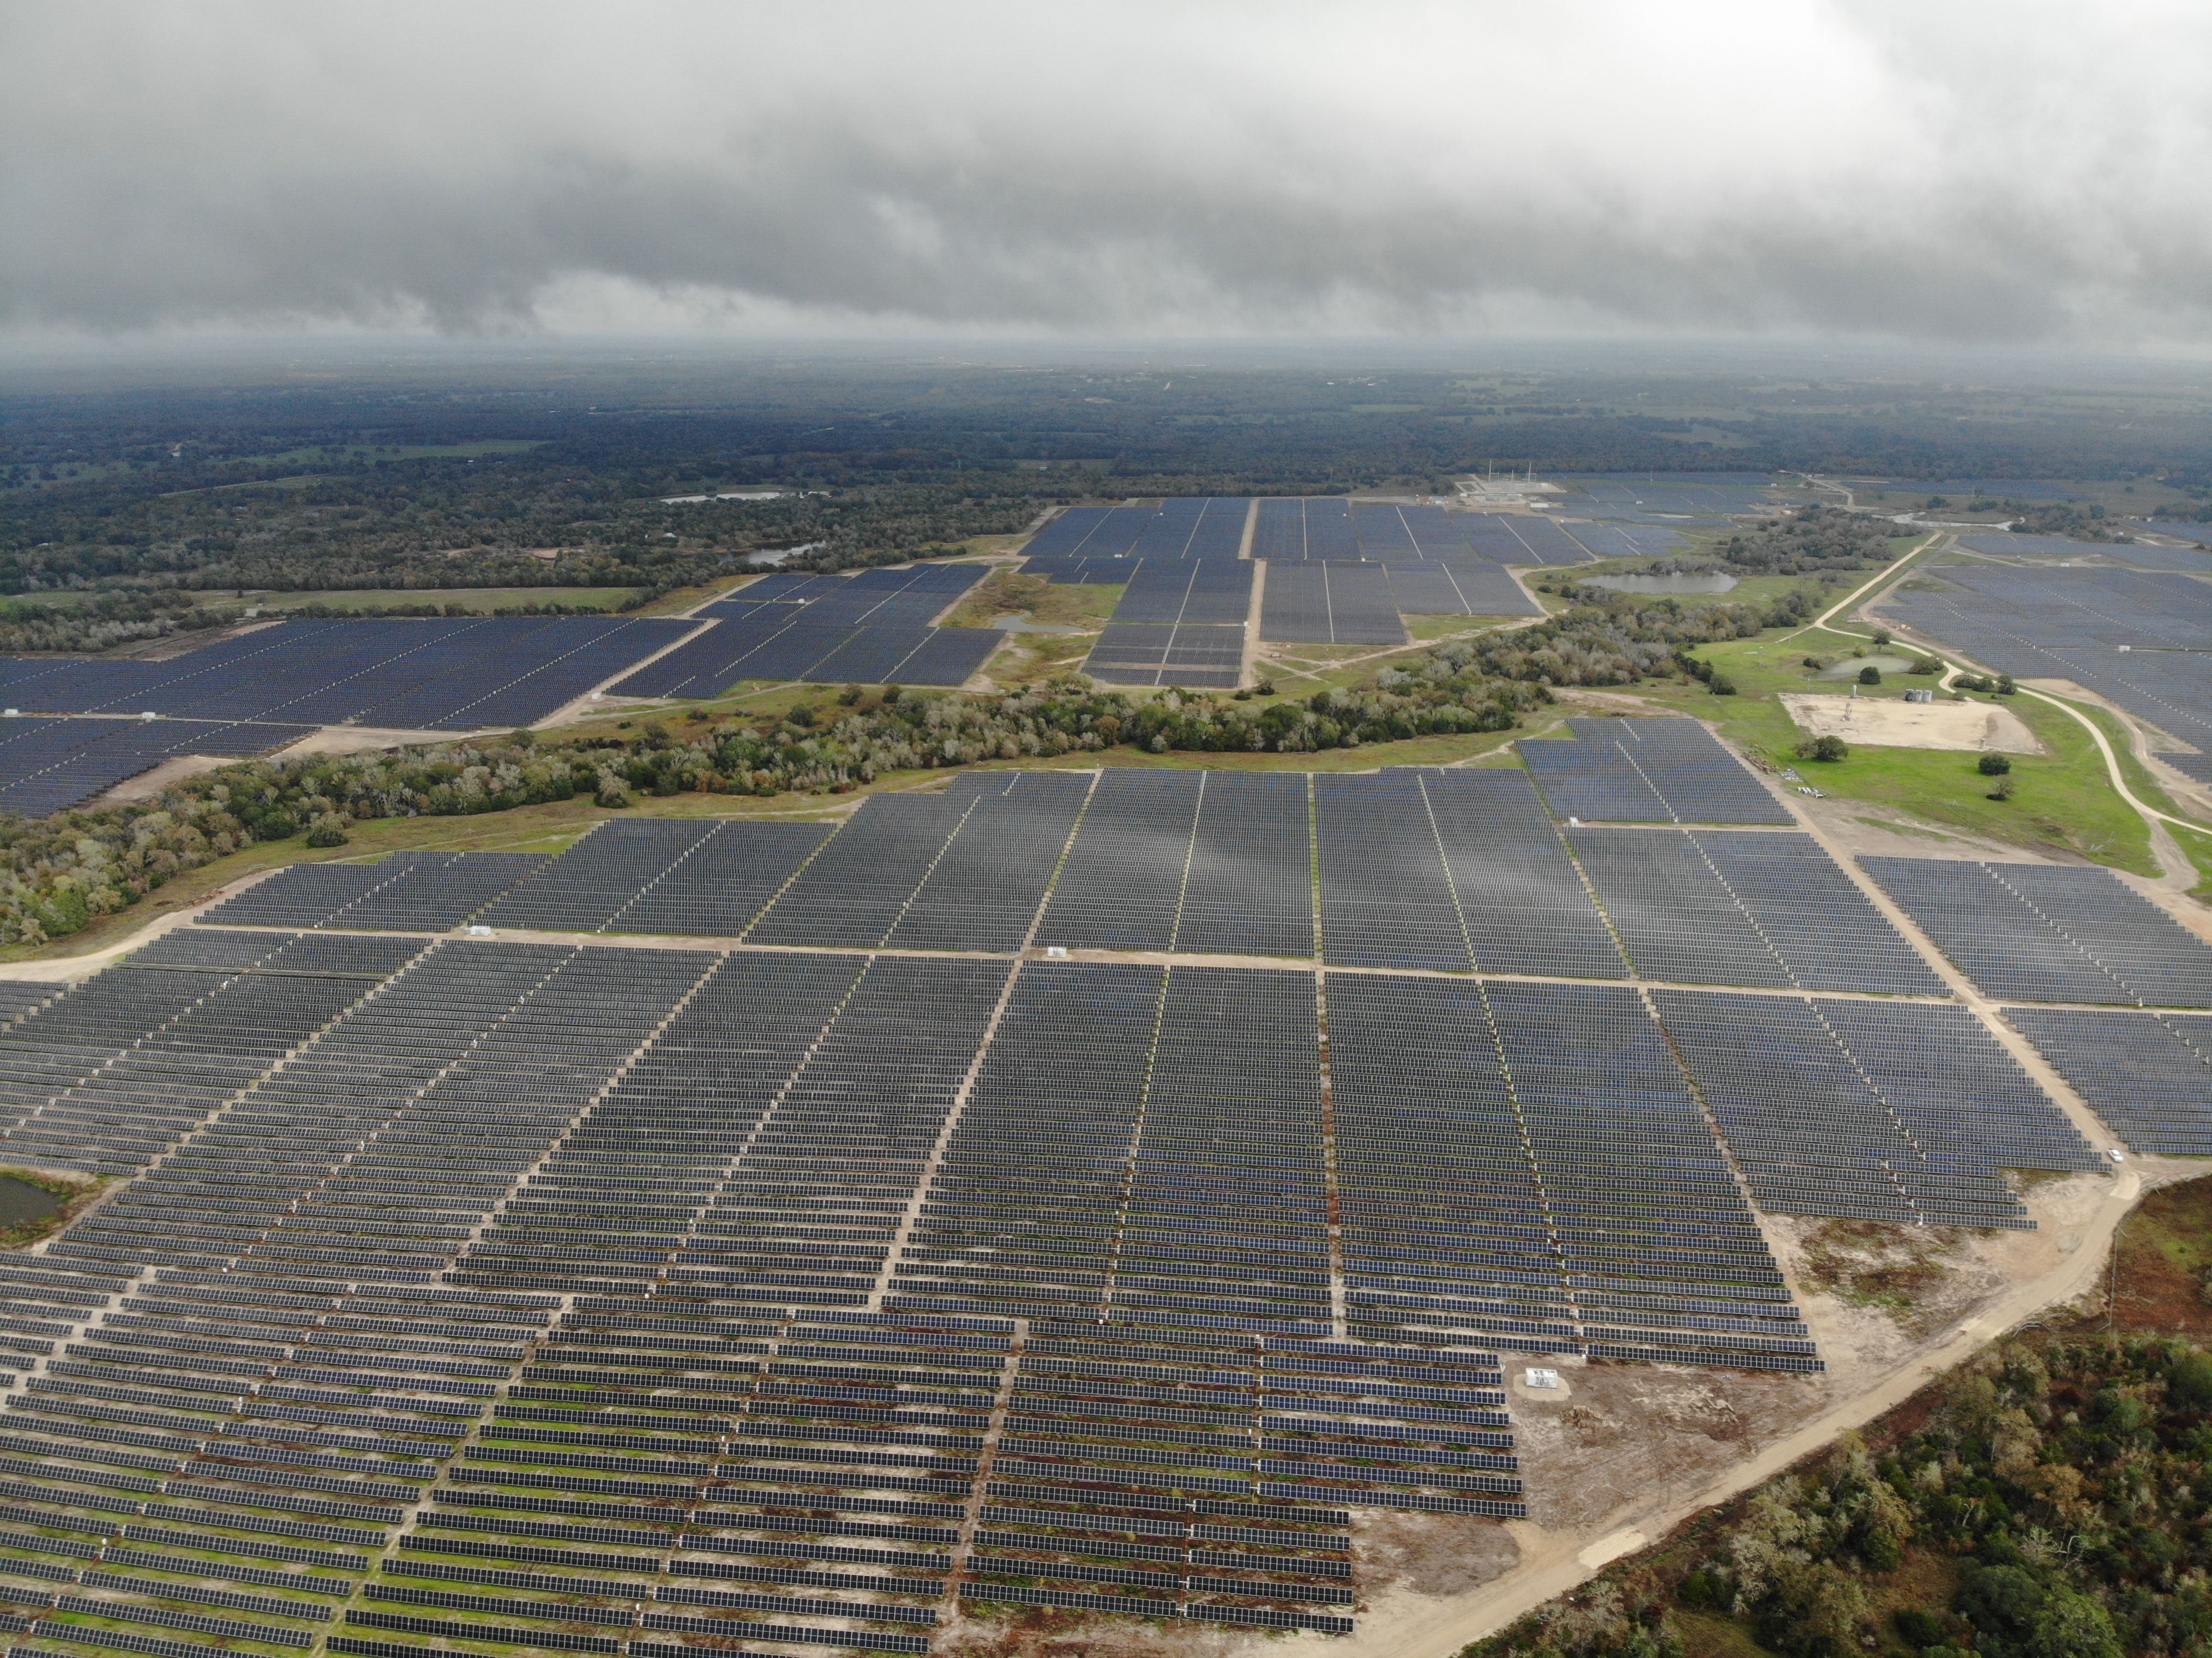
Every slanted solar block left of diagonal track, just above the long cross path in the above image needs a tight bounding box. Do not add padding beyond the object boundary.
[1568,829,1949,997]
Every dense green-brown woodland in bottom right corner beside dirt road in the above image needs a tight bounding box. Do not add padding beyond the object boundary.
[1462,1333,2212,1658]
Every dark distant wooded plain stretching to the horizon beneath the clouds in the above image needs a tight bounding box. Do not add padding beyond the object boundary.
[0,361,2212,605]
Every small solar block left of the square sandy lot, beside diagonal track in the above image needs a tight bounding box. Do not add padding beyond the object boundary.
[1515,718,1794,825]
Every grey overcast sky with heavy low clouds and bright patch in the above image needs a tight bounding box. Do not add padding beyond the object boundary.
[0,0,2212,349]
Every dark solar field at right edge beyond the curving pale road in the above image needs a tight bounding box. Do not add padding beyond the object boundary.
[1883,566,2212,749]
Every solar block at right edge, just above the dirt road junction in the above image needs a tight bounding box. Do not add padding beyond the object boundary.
[2004,1008,2212,1156]
